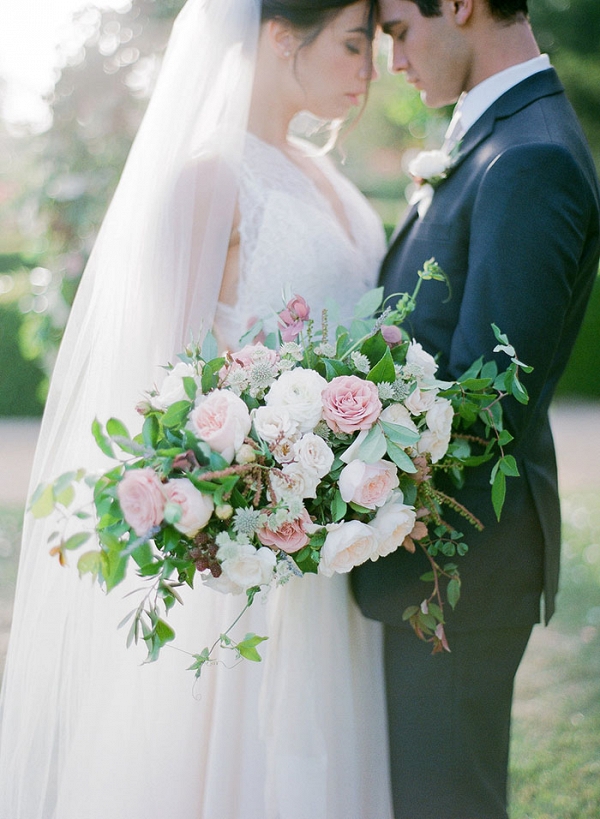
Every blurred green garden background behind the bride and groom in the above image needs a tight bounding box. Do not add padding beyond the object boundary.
[0,0,600,819]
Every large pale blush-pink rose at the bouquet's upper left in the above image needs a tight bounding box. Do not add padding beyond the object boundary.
[189,390,252,463]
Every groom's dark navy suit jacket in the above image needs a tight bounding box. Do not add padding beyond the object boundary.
[353,69,600,630]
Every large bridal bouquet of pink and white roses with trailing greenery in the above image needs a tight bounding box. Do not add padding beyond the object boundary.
[32,260,530,674]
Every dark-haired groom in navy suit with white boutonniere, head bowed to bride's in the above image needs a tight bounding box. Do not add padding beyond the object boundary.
[353,0,600,819]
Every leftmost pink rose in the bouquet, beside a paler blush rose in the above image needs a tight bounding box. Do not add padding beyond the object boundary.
[117,467,165,537]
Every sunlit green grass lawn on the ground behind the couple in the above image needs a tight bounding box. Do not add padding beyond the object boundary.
[0,491,600,819]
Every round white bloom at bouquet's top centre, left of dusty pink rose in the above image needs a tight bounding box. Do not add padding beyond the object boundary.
[265,367,327,433]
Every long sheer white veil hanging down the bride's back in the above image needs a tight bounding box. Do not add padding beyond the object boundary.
[0,0,260,819]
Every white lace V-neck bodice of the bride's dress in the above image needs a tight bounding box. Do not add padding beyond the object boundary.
[216,134,385,346]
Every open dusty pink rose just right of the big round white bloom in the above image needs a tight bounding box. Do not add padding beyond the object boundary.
[321,375,382,432]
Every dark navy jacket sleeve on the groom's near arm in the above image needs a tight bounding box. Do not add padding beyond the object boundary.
[449,144,593,435]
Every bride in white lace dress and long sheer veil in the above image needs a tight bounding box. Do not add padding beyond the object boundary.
[0,0,392,819]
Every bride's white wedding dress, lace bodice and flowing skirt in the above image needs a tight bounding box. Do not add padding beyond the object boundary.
[2,136,392,819]
